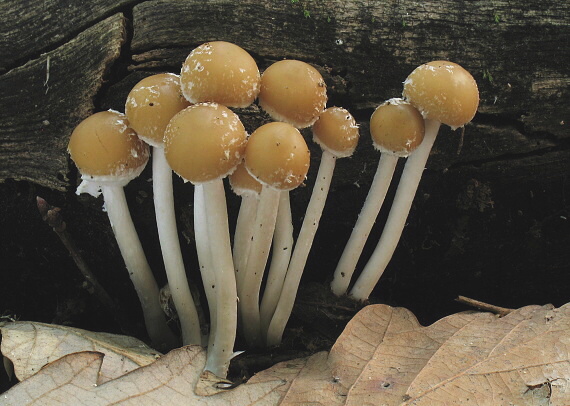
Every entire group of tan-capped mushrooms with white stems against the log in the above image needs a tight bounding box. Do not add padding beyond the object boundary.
[69,41,478,377]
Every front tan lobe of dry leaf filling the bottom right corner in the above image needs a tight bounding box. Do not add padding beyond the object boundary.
[407,305,570,405]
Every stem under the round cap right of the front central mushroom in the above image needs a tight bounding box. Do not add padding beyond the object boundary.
[239,185,282,347]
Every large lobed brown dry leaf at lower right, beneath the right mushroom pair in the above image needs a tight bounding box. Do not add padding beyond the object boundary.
[329,305,570,405]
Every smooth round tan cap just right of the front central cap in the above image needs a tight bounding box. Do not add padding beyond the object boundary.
[245,122,310,190]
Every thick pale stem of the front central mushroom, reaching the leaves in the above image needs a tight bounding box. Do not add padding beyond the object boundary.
[202,179,237,378]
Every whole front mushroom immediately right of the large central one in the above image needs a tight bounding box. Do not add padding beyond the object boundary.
[239,122,310,346]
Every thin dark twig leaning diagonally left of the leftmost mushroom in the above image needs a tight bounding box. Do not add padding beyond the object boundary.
[36,196,137,335]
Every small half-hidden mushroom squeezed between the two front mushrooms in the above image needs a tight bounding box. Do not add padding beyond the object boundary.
[229,162,261,296]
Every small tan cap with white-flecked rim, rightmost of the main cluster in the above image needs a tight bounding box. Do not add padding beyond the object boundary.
[313,107,360,157]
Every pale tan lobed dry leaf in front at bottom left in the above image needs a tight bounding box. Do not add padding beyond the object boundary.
[0,346,284,406]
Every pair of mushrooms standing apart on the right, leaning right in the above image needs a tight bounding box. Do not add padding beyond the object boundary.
[331,61,479,301]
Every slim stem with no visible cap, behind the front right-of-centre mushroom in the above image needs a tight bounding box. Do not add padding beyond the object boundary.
[260,191,293,337]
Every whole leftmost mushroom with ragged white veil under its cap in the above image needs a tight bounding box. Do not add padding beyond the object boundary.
[68,110,178,349]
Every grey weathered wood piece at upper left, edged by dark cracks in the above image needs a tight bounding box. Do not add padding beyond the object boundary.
[0,14,125,190]
